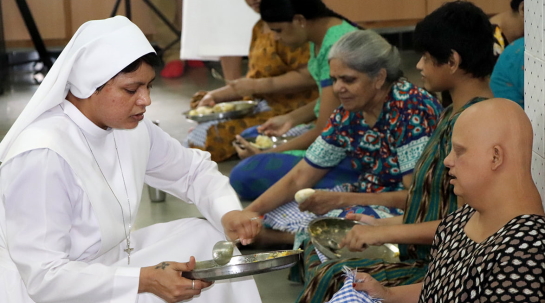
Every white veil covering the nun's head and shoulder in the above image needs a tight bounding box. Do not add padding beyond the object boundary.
[0,16,155,162]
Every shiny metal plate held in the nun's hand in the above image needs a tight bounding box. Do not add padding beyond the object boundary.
[182,250,303,281]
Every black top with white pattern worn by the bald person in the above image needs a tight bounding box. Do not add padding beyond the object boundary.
[419,205,545,303]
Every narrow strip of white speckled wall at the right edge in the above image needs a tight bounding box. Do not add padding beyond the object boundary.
[524,0,545,206]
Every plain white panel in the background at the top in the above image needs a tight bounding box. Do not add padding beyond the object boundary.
[181,0,259,60]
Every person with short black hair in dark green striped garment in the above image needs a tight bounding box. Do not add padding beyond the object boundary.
[298,1,495,303]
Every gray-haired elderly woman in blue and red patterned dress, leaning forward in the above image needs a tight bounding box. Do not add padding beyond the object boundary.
[246,30,442,247]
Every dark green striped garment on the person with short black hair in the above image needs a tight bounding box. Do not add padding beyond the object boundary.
[296,98,484,303]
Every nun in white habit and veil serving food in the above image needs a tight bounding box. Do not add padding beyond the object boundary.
[0,17,261,303]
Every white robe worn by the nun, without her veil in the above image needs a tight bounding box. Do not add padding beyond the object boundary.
[0,101,261,303]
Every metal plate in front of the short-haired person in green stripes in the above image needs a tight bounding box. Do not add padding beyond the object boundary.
[308,217,399,262]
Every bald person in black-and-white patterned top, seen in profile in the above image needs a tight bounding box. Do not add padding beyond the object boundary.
[345,99,545,303]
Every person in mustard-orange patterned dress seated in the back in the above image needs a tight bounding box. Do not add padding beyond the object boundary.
[188,0,318,162]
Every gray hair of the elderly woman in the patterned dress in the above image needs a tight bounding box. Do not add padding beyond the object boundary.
[328,30,403,83]
